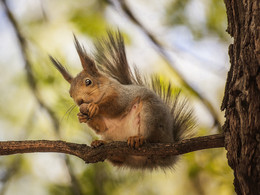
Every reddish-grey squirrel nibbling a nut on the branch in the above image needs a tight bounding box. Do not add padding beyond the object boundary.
[50,30,195,169]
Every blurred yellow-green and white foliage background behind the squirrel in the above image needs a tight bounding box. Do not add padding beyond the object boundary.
[0,0,234,195]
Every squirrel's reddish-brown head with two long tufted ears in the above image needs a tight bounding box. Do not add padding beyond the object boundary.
[50,36,110,106]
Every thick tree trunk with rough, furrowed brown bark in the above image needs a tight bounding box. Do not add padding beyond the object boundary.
[221,0,260,195]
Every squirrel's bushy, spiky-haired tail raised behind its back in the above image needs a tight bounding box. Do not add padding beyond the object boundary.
[95,31,195,142]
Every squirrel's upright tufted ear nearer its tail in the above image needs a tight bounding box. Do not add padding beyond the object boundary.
[74,35,99,76]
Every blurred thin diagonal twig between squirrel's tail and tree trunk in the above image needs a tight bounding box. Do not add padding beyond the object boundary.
[107,0,222,132]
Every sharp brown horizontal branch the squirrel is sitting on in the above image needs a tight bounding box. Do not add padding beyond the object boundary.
[0,134,224,163]
